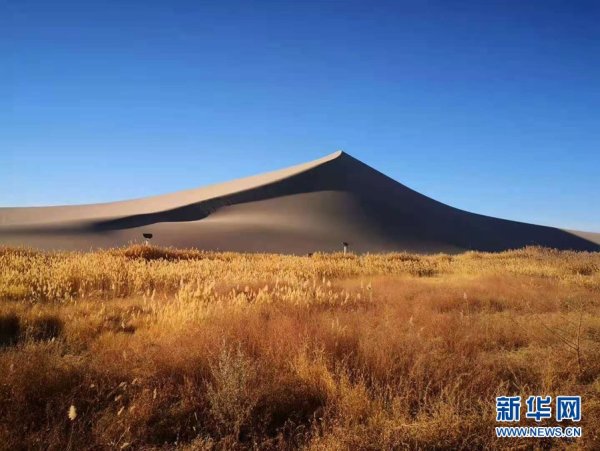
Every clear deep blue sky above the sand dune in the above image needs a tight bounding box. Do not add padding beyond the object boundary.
[0,0,600,231]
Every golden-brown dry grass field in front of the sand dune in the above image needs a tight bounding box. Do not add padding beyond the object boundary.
[0,246,600,450]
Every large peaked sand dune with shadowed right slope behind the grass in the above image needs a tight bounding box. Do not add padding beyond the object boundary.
[0,152,600,253]
